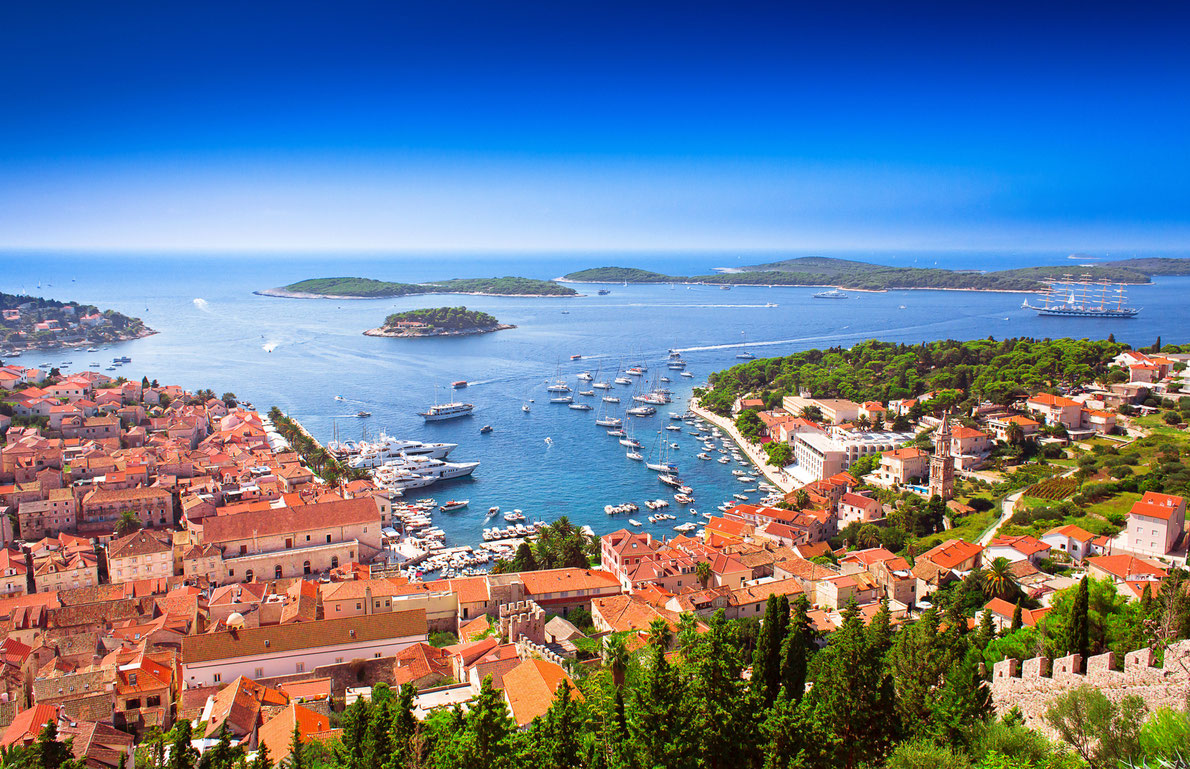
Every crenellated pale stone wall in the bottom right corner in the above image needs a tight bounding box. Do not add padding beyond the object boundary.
[991,640,1190,721]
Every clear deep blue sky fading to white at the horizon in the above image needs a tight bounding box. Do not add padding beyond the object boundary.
[0,0,1190,252]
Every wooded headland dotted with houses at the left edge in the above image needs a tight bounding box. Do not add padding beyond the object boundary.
[0,293,156,351]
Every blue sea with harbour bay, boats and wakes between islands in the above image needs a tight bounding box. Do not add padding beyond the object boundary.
[0,252,1190,552]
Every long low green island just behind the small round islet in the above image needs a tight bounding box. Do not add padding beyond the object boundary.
[256,276,578,299]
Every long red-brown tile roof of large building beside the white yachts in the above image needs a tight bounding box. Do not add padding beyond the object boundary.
[202,496,380,543]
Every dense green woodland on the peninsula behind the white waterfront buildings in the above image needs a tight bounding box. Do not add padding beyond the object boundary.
[700,338,1151,415]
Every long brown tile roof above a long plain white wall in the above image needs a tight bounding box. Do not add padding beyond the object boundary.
[182,608,426,663]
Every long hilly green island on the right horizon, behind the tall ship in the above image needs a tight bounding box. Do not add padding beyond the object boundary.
[563,256,1190,292]
